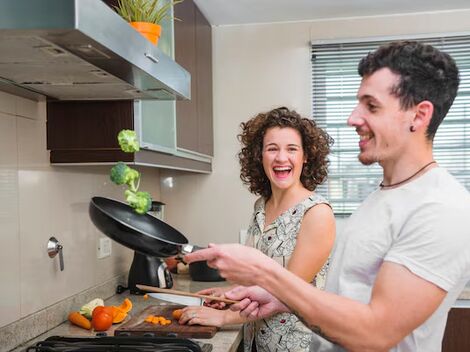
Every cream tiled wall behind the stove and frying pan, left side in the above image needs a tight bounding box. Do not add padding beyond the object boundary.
[0,92,160,328]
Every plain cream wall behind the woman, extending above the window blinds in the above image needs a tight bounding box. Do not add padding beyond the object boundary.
[162,10,470,245]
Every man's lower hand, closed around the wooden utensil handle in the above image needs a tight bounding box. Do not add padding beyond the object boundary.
[225,286,289,320]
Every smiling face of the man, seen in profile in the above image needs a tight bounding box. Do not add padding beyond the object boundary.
[348,68,414,166]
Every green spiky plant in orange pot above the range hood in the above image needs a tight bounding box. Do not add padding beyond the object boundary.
[115,0,183,45]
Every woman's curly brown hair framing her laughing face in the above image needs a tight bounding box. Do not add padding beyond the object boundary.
[238,107,333,199]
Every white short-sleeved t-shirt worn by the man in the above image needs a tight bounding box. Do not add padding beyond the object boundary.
[310,167,470,352]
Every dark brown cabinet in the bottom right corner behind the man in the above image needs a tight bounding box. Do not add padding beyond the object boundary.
[442,308,470,352]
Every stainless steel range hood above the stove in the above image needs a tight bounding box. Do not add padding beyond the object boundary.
[0,0,191,100]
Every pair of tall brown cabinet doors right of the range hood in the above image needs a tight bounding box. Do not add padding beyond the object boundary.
[175,0,214,156]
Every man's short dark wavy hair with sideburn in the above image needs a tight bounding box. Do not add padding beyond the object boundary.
[358,41,459,140]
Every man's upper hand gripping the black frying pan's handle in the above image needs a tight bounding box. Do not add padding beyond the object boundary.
[184,244,279,286]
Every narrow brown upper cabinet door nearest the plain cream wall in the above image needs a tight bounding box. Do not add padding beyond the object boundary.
[196,4,214,155]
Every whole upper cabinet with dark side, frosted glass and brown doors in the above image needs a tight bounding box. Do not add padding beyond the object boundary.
[47,0,213,172]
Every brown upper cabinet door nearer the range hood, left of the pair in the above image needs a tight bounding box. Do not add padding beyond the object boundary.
[174,0,199,151]
